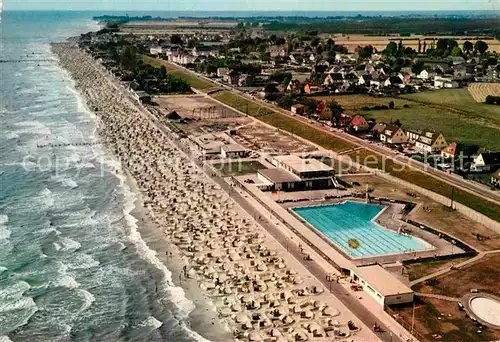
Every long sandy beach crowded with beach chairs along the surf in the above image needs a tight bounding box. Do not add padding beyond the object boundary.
[53,44,377,341]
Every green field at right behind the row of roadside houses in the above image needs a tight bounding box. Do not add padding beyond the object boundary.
[321,89,500,151]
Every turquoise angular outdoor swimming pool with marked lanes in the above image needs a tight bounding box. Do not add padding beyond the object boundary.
[292,201,432,258]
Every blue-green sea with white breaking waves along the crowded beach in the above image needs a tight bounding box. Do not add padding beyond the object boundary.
[0,12,211,342]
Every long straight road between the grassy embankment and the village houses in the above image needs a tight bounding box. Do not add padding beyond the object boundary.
[166,60,500,205]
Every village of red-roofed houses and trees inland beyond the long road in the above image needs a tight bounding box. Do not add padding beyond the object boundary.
[81,21,500,188]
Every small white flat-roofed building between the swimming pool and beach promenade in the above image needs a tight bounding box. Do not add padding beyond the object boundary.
[351,265,414,306]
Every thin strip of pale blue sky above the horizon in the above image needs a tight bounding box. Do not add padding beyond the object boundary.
[0,0,500,11]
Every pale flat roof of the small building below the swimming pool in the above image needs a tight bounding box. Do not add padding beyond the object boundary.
[352,265,413,297]
